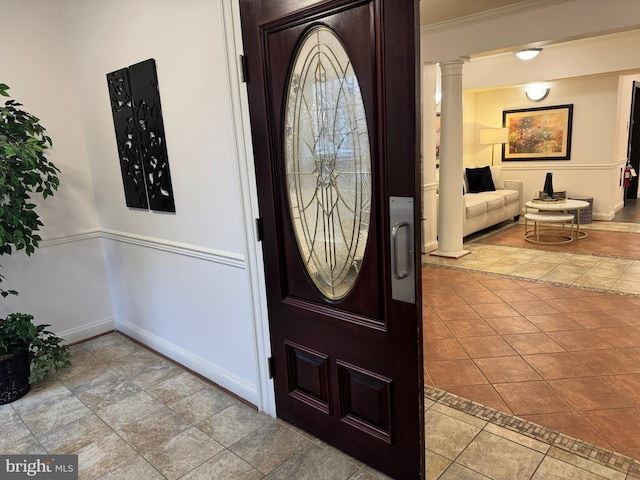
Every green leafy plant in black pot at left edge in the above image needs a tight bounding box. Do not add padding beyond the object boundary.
[0,83,70,404]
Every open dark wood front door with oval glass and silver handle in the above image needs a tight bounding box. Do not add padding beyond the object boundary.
[240,0,424,479]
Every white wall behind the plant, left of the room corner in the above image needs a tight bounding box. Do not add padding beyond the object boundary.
[0,0,113,341]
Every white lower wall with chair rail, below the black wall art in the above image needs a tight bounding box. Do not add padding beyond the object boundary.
[102,230,266,407]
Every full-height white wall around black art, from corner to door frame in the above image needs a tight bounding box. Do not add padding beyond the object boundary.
[62,0,266,404]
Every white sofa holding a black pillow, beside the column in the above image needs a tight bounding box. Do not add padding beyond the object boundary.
[463,165,524,237]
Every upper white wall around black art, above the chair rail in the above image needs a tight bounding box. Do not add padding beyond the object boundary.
[63,0,244,253]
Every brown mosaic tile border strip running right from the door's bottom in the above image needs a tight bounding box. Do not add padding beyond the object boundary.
[424,385,640,476]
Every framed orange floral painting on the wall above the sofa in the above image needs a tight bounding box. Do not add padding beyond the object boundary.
[502,105,573,161]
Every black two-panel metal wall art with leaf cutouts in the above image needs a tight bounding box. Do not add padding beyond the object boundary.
[107,59,176,212]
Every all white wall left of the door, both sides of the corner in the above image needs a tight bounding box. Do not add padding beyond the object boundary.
[0,0,264,411]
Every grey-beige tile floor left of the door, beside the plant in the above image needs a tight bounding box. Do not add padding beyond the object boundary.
[0,333,388,480]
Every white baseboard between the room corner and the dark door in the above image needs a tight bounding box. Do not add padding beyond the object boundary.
[115,318,260,405]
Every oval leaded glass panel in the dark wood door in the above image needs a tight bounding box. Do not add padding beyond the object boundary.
[284,26,371,300]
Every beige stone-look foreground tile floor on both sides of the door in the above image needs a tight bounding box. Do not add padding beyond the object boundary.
[0,333,632,480]
